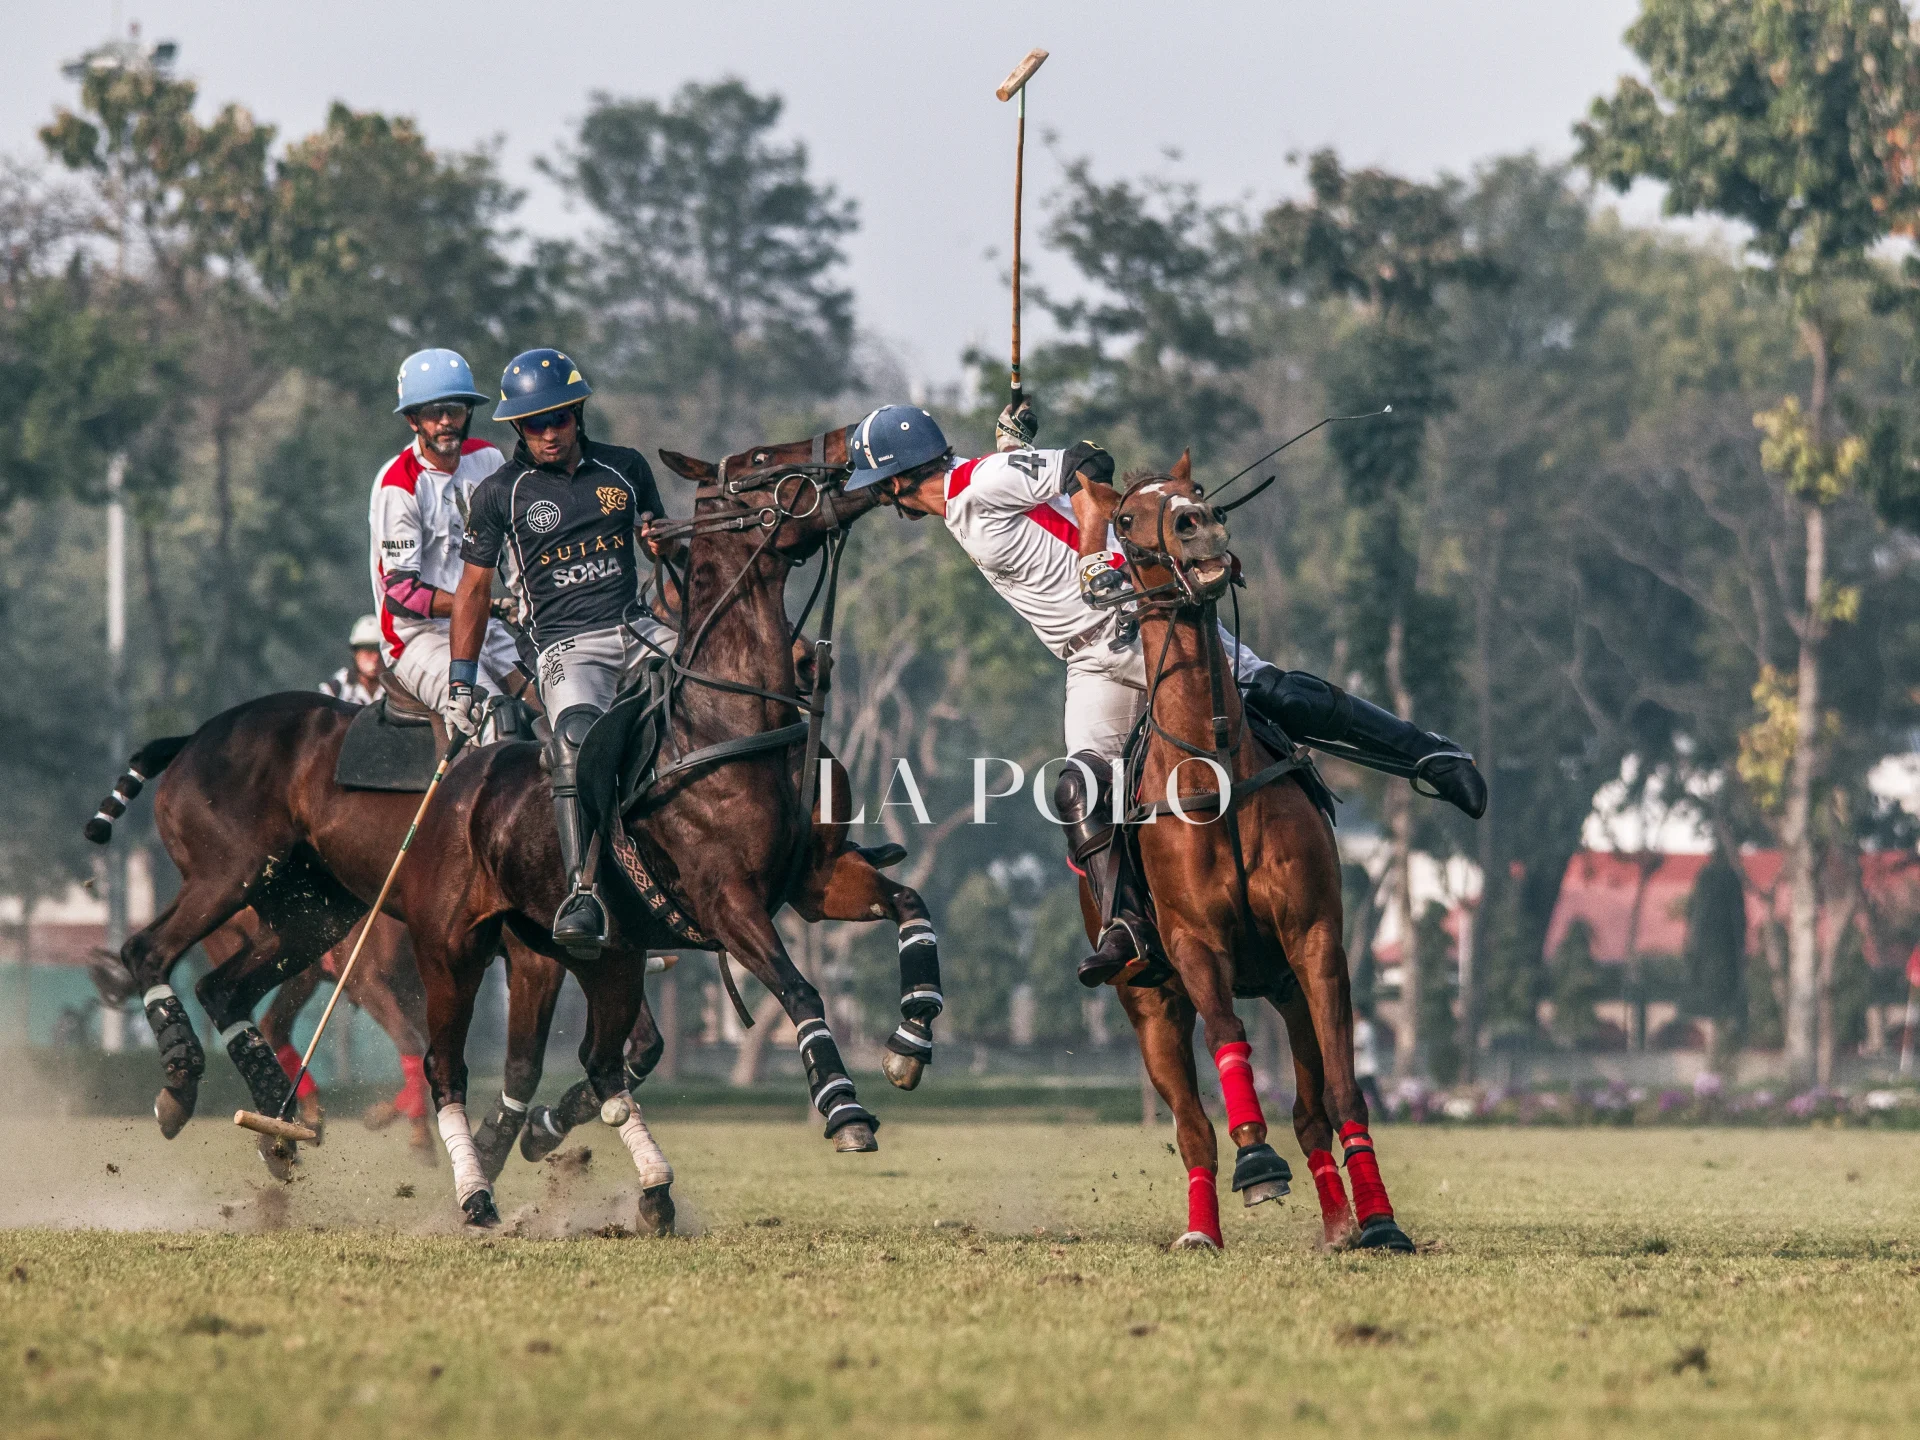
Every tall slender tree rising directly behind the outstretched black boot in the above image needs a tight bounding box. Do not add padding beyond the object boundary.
[1252,150,1500,1073]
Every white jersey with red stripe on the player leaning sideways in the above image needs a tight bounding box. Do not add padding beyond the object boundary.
[947,449,1121,660]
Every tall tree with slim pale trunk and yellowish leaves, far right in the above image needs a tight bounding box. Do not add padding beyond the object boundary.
[1574,0,1920,1079]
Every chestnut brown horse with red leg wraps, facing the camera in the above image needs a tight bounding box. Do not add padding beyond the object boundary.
[1081,455,1413,1250]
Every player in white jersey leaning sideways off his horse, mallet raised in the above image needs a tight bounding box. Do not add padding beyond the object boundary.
[847,405,1486,987]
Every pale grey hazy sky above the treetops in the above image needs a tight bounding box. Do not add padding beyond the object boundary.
[0,0,1651,380]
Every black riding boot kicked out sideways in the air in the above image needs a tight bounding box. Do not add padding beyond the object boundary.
[1242,664,1486,820]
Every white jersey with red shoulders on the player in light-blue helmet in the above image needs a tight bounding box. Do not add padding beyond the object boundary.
[367,440,507,664]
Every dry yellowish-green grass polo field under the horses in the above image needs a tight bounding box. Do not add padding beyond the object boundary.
[0,1119,1920,1440]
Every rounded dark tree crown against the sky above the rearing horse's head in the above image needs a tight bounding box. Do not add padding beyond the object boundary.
[543,79,858,453]
